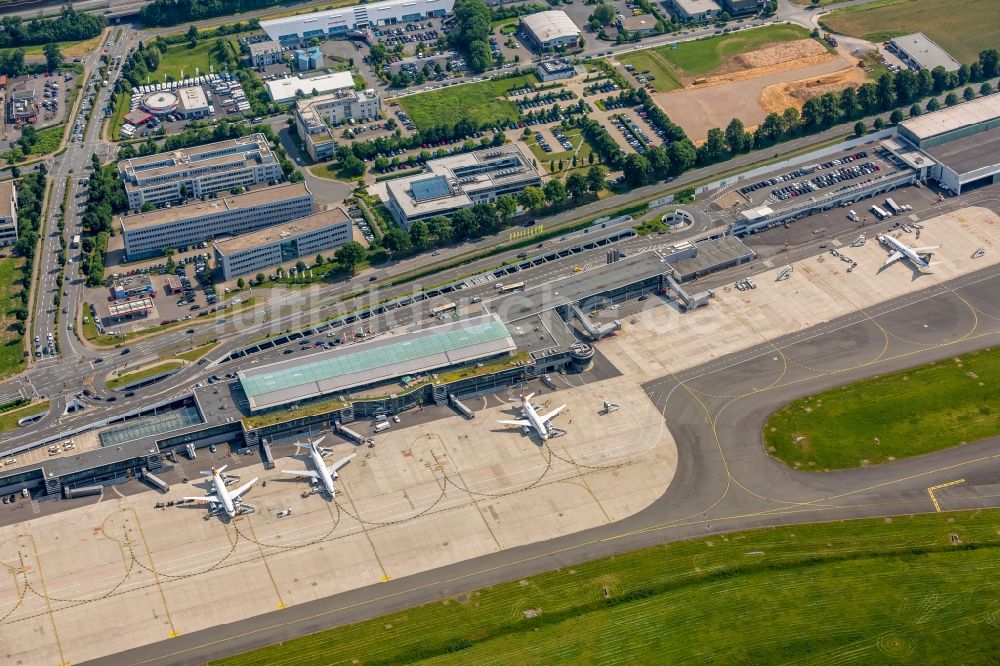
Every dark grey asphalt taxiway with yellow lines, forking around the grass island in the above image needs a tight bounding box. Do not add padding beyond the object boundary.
[91,252,1000,666]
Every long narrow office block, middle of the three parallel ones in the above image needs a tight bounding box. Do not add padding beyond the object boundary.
[119,183,313,260]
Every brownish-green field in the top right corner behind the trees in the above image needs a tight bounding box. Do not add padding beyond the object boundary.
[822,0,1000,63]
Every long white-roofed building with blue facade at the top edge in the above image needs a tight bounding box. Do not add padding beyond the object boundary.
[260,0,455,43]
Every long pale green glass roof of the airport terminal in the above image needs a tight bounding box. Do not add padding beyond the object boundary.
[241,319,509,398]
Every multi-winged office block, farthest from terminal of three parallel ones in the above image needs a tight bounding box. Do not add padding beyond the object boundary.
[118,134,283,210]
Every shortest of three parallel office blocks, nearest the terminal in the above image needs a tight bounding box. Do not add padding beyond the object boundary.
[215,208,351,280]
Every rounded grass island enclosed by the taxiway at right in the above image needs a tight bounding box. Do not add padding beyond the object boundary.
[764,348,1000,470]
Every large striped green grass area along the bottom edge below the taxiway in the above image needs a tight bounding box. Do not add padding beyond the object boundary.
[214,510,1000,666]
